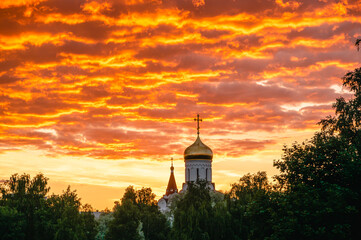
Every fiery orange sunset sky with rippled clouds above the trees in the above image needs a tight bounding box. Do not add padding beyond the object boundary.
[0,0,361,210]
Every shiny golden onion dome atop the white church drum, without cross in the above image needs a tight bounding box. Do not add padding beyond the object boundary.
[184,135,213,161]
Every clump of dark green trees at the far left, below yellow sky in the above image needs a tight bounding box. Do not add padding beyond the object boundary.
[0,174,96,240]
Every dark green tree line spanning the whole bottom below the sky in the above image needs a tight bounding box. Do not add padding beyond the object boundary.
[0,41,361,240]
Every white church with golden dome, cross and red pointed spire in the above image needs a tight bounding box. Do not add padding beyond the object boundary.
[158,114,215,212]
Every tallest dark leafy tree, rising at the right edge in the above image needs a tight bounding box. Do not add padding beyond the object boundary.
[273,64,361,239]
